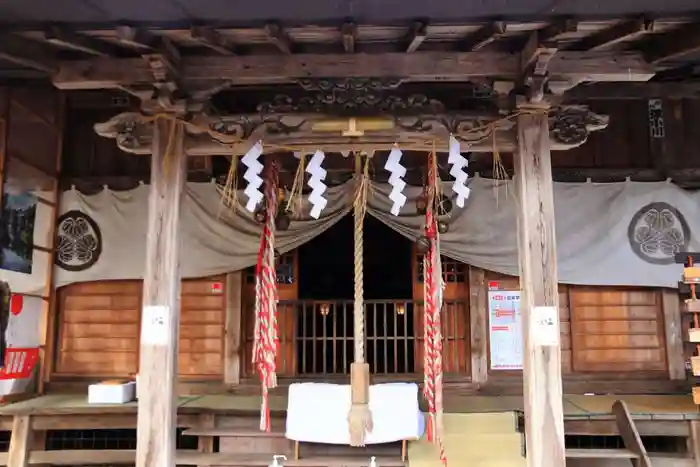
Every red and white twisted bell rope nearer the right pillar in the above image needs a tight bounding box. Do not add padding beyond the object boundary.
[423,153,447,465]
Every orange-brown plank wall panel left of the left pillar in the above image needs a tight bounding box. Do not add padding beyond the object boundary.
[56,281,141,377]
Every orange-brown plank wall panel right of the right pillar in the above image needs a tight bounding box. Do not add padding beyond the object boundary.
[570,287,667,373]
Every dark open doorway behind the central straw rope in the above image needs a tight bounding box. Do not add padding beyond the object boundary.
[297,214,414,375]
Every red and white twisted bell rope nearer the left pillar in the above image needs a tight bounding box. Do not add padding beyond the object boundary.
[253,162,279,431]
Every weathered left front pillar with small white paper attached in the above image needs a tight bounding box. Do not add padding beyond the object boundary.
[136,119,186,467]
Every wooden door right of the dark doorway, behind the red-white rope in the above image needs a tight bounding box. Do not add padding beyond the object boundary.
[412,245,471,374]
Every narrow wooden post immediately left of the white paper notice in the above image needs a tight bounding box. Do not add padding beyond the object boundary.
[469,266,489,385]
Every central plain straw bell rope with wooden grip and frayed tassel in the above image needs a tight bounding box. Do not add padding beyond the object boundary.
[348,154,373,446]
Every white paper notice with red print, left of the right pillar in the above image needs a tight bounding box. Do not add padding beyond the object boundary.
[488,290,523,370]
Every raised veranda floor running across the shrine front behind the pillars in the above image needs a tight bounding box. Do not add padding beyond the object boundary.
[0,394,700,420]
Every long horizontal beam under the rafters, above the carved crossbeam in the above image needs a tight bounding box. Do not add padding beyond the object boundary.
[54,52,654,90]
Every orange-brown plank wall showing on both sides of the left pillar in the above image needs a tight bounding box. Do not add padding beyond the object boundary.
[54,277,226,380]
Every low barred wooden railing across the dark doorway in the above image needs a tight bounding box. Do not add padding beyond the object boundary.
[246,300,469,376]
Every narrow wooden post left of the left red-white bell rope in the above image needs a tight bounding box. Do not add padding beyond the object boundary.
[224,271,243,385]
